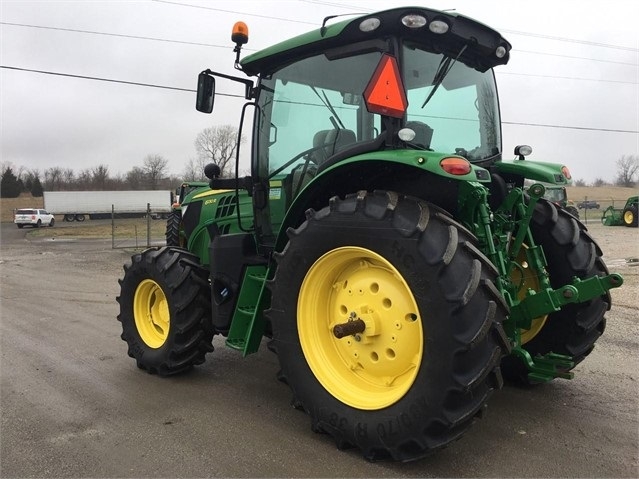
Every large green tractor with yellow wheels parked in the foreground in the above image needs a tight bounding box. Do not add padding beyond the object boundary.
[118,7,623,461]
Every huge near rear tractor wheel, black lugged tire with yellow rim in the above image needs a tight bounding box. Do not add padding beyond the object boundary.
[266,192,509,461]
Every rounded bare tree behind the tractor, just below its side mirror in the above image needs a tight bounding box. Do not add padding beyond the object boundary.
[195,125,244,176]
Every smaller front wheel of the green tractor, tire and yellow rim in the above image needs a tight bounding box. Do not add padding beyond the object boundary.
[117,247,213,376]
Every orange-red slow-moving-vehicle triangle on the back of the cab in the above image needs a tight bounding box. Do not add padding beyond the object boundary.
[364,54,408,118]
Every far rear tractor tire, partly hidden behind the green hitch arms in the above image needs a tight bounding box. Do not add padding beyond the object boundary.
[502,199,610,384]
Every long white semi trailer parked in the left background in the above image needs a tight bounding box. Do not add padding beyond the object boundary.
[44,190,172,221]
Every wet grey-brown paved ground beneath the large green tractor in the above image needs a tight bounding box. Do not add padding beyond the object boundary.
[0,224,639,478]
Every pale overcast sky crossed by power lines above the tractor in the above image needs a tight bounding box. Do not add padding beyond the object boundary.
[0,0,639,182]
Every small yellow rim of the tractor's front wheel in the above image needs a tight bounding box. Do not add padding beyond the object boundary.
[133,279,170,349]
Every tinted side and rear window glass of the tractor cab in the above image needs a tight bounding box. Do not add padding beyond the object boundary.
[255,43,501,177]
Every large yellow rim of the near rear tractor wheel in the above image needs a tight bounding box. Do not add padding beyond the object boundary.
[297,246,424,410]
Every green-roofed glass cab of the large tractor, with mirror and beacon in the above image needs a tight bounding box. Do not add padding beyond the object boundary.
[198,8,511,251]
